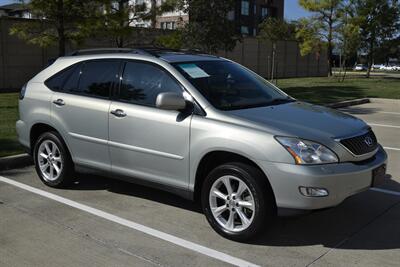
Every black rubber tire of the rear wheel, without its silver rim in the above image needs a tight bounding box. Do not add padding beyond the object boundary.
[33,132,73,187]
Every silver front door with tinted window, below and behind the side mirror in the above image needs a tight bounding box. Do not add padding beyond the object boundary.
[109,61,192,189]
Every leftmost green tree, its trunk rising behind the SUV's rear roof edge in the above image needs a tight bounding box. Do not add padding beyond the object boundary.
[10,0,93,56]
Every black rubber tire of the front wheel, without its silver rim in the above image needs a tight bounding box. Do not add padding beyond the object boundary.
[201,163,274,241]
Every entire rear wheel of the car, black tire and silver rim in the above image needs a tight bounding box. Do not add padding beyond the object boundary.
[33,132,74,188]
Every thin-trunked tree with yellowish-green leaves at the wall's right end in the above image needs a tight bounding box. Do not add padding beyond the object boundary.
[299,0,343,75]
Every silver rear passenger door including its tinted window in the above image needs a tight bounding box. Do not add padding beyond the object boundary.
[52,59,120,170]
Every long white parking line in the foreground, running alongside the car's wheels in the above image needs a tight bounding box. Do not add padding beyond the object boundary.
[0,176,258,266]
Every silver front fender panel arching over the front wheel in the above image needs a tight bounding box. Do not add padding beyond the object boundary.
[189,116,294,191]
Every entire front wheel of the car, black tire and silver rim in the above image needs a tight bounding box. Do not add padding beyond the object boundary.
[201,162,276,242]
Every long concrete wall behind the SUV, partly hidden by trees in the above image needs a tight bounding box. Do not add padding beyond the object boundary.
[0,18,327,90]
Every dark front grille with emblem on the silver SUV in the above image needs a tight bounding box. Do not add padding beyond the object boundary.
[340,130,378,155]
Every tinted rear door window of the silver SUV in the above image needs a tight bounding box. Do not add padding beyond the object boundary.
[70,60,119,98]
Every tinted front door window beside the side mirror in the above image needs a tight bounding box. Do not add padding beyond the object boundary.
[119,62,182,106]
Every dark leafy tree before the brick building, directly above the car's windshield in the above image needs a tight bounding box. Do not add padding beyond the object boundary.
[183,0,241,53]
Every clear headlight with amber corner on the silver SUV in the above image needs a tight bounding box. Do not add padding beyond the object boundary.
[276,137,339,164]
